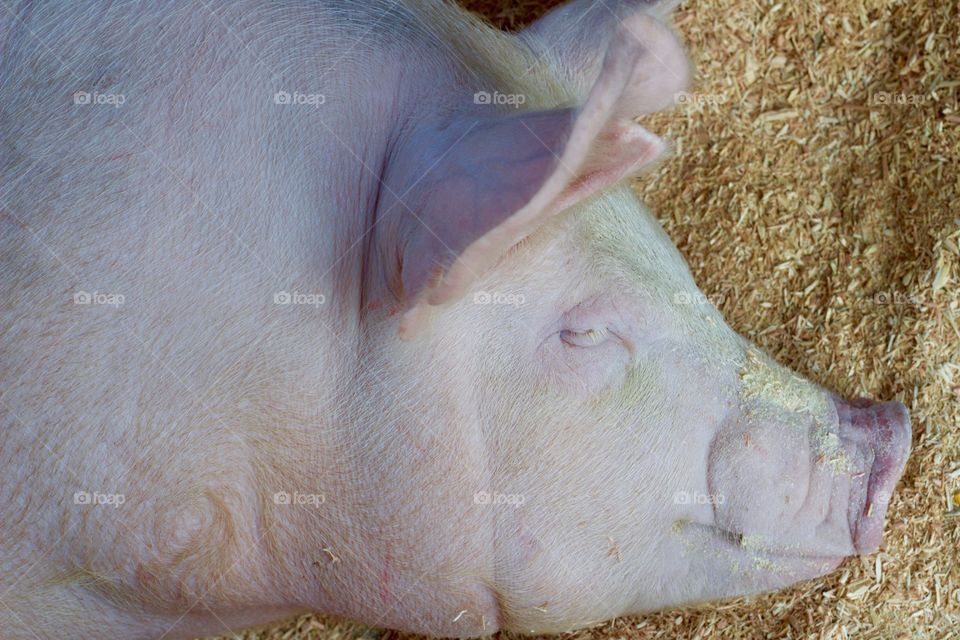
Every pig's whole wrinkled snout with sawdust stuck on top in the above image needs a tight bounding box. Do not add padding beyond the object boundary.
[707,372,911,578]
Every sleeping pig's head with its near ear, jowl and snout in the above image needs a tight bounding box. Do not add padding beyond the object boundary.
[358,6,910,630]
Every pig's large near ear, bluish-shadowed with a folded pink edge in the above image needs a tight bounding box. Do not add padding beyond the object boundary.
[394,15,687,338]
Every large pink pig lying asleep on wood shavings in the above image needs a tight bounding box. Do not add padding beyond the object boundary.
[0,0,911,639]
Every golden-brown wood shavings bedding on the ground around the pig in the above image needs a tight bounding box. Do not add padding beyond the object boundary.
[208,0,960,640]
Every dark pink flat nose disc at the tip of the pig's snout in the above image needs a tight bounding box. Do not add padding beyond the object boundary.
[833,397,911,554]
